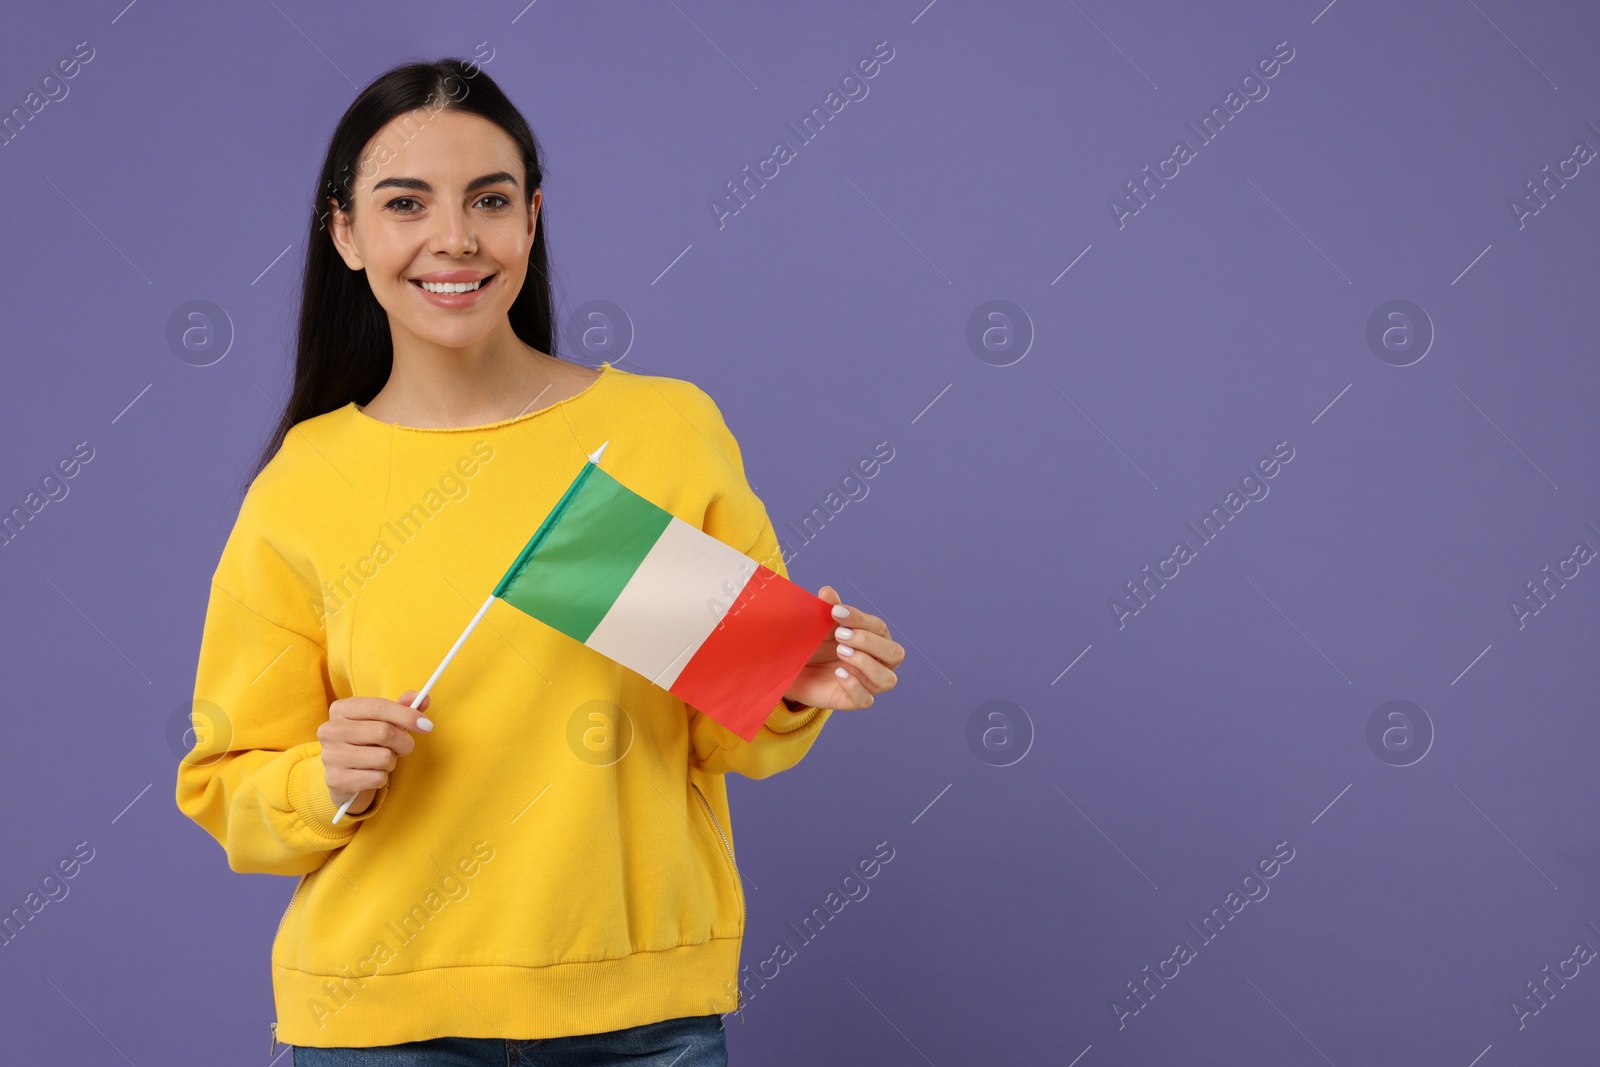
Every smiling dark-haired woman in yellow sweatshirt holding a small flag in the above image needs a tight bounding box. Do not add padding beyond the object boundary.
[178,59,904,1067]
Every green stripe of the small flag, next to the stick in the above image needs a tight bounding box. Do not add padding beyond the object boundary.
[494,462,672,641]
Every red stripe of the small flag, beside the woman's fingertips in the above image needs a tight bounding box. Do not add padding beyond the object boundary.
[670,563,834,741]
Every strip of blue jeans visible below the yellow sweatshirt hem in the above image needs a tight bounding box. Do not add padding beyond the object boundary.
[293,1016,728,1067]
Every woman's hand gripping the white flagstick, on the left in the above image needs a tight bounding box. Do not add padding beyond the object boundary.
[317,689,434,814]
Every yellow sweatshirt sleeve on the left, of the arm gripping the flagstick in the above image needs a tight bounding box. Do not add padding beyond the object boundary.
[176,499,389,875]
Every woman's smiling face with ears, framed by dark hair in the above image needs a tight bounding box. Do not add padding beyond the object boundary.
[330,109,541,349]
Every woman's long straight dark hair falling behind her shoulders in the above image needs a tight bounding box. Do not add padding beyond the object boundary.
[243,59,555,490]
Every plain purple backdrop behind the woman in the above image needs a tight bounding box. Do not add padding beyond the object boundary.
[0,0,1600,1067]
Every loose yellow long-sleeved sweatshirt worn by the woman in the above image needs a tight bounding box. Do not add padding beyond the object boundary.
[176,363,832,1046]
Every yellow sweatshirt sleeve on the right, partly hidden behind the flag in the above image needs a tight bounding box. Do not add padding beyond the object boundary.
[686,379,834,777]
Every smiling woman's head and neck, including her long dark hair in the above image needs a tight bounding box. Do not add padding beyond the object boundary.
[238,61,582,467]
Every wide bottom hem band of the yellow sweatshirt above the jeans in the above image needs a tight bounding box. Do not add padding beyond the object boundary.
[272,940,741,1048]
